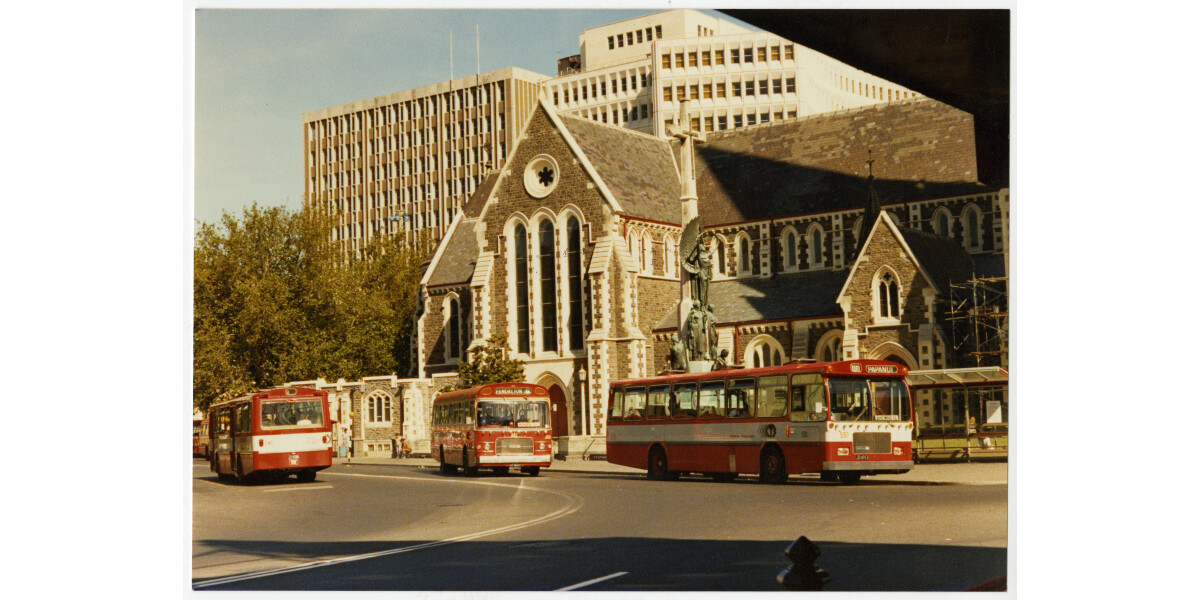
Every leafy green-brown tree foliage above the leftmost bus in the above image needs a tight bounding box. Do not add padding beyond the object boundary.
[192,205,434,408]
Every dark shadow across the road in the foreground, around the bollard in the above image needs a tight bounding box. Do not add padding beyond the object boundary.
[193,532,1008,592]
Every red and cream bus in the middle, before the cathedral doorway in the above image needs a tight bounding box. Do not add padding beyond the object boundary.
[430,383,553,476]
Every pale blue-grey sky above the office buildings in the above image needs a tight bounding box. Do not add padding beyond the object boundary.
[194,2,758,229]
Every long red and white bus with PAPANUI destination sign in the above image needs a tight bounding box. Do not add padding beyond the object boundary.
[606,360,913,484]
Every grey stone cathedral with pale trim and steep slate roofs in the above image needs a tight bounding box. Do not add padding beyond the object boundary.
[408,98,1009,454]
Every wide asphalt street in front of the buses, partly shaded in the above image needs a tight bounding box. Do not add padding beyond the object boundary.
[192,461,1008,592]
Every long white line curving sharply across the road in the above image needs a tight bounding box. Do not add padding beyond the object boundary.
[192,472,585,589]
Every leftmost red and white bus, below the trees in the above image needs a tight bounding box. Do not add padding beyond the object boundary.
[209,388,334,482]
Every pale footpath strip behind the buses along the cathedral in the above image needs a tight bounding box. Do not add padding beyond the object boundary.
[334,457,1008,485]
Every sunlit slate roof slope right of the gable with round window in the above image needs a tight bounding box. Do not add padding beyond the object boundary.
[558,114,680,224]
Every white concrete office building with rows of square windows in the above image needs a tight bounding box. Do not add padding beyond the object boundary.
[544,10,920,136]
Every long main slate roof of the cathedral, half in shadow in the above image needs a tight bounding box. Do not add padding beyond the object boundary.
[686,98,989,226]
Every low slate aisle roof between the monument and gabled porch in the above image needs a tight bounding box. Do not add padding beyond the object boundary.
[654,270,847,330]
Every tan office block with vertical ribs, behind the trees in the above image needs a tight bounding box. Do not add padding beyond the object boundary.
[304,67,547,256]
